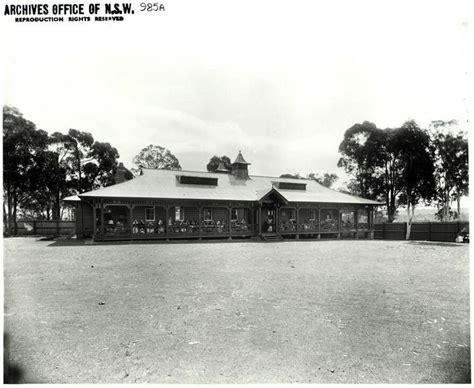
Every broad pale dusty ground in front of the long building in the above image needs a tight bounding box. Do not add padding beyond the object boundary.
[4,238,470,383]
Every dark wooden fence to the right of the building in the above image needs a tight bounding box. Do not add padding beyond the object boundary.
[374,222,469,241]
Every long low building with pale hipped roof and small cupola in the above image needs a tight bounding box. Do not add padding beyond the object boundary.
[64,152,379,241]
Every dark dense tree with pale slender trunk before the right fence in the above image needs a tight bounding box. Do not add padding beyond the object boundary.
[389,120,435,240]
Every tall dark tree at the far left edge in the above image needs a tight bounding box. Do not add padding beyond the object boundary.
[3,106,48,234]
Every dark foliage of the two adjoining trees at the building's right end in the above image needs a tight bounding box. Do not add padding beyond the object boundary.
[338,121,433,230]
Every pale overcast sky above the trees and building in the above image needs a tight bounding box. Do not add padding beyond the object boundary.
[0,0,471,191]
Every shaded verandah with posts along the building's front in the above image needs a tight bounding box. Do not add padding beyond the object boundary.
[89,200,373,239]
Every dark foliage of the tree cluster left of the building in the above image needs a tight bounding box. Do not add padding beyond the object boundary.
[3,106,125,230]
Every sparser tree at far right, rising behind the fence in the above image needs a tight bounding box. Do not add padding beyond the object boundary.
[430,120,469,221]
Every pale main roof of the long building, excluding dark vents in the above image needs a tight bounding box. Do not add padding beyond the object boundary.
[79,169,380,205]
